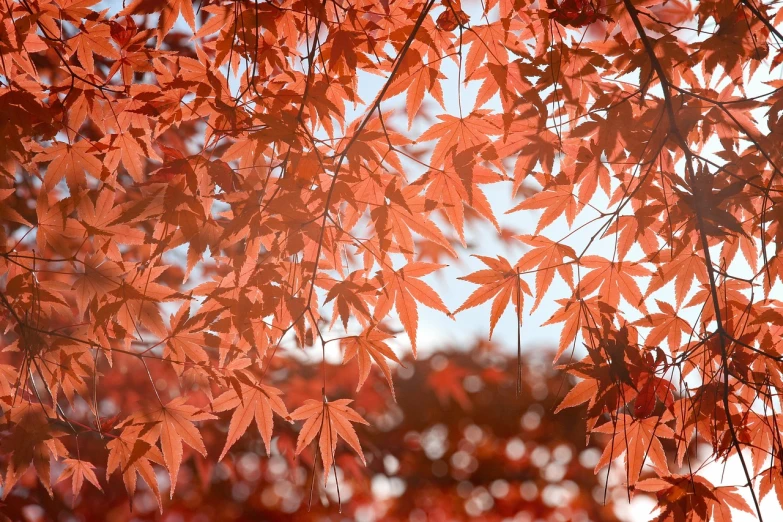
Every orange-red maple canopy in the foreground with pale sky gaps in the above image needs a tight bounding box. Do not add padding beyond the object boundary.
[0,0,783,521]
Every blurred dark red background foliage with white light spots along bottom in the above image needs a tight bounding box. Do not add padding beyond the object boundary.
[0,344,616,522]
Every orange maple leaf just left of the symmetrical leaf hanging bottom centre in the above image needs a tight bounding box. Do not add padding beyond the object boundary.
[212,382,289,460]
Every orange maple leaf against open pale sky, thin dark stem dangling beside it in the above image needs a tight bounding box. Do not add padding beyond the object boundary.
[454,256,531,338]
